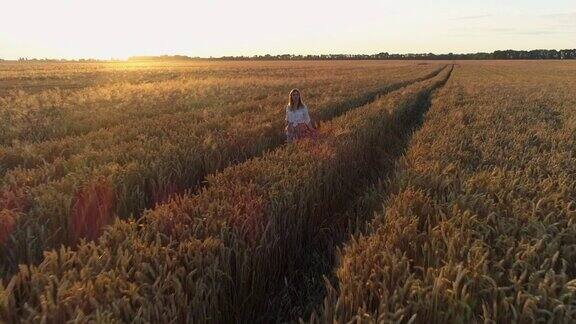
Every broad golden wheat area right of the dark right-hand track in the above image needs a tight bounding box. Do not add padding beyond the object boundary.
[310,62,576,323]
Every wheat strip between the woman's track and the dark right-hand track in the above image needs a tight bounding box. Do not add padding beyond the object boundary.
[0,70,449,322]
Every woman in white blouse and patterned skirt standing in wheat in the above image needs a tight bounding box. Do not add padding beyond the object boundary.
[286,89,316,142]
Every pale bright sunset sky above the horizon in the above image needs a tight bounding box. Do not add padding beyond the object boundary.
[0,0,576,59]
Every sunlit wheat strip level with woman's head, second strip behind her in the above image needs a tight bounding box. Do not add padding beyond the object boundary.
[0,62,430,146]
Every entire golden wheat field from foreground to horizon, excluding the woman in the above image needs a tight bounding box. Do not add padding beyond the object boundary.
[0,61,576,323]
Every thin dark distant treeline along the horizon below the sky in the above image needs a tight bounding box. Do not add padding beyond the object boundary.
[5,49,576,62]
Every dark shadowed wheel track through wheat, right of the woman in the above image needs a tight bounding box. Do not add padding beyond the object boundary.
[258,66,454,323]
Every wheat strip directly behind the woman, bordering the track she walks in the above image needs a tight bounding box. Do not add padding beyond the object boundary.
[0,68,440,272]
